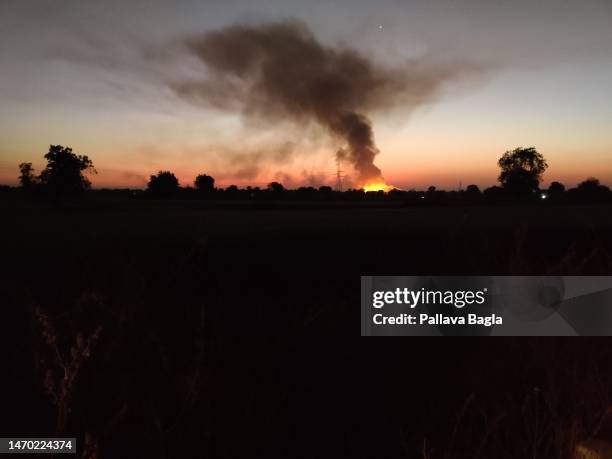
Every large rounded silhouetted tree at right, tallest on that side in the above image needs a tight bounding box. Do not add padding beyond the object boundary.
[497,147,548,197]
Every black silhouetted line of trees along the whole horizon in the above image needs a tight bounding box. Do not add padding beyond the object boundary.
[9,145,612,203]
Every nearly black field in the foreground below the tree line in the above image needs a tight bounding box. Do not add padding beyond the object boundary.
[0,197,612,458]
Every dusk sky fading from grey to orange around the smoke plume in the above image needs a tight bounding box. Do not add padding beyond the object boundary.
[0,0,612,189]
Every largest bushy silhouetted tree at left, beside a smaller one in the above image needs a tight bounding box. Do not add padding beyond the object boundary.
[38,145,96,195]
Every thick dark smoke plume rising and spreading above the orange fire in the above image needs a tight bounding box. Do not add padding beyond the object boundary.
[173,20,474,183]
